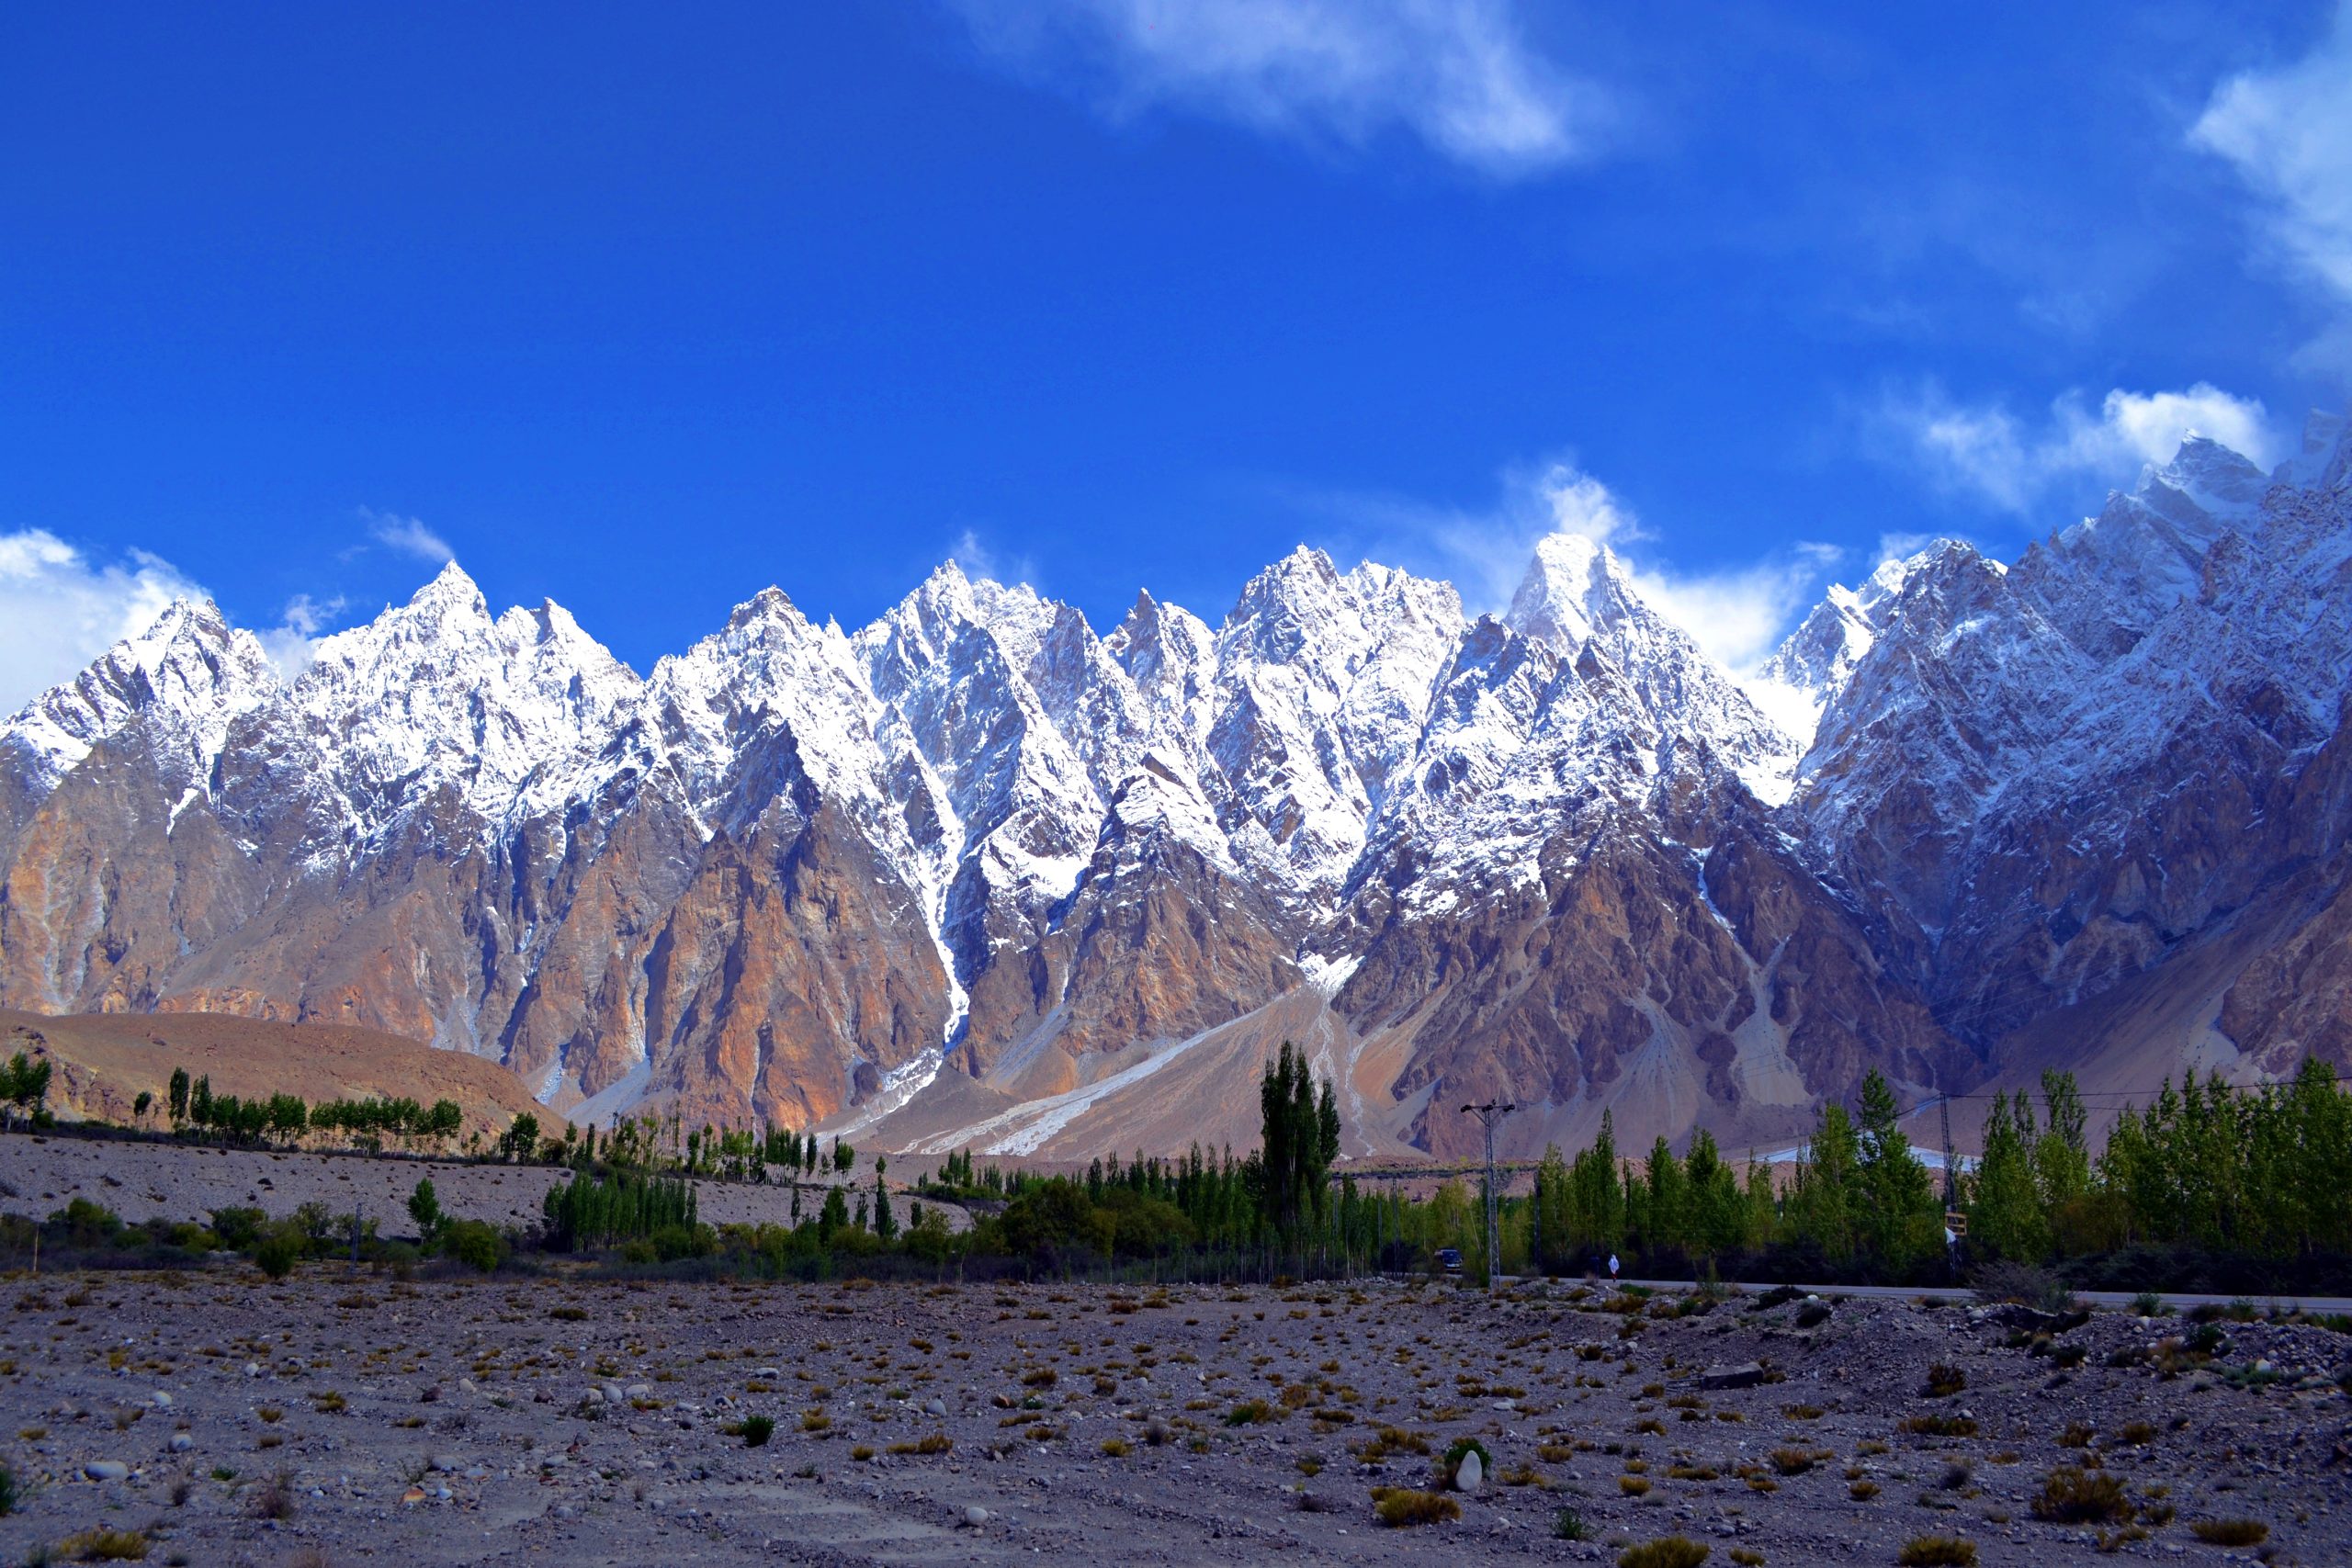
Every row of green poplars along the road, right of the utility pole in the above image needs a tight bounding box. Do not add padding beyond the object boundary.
[1524,1060,2352,1277]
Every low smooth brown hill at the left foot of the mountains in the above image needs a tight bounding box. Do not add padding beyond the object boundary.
[0,1009,548,1134]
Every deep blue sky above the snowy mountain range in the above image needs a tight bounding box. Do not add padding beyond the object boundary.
[0,0,2352,696]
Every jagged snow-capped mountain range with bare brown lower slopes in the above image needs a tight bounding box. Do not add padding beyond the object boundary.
[0,421,2352,1155]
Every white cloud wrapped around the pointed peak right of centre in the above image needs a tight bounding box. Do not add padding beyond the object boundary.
[1315,458,1841,674]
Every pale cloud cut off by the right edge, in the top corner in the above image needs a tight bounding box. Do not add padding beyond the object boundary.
[2189,0,2352,312]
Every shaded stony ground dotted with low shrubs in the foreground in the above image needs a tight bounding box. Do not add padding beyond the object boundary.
[0,1265,2352,1568]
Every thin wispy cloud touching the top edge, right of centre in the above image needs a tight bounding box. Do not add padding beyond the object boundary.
[945,0,1609,179]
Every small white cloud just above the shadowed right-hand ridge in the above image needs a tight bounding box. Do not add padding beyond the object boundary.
[1879,381,2277,513]
